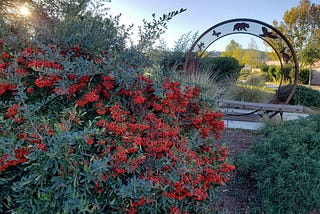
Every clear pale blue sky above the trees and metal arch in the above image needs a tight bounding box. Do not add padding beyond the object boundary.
[109,0,320,51]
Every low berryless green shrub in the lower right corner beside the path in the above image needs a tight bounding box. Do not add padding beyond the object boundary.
[236,115,320,213]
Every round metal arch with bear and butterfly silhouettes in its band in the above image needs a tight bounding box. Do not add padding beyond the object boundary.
[184,18,299,104]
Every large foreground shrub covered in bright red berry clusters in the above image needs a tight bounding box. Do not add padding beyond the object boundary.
[0,41,234,213]
